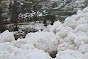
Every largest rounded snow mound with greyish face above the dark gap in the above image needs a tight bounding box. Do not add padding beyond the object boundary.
[25,32,58,53]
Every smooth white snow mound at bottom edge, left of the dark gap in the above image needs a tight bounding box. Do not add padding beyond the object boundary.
[12,49,51,59]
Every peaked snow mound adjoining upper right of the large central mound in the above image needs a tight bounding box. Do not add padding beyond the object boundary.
[45,21,73,38]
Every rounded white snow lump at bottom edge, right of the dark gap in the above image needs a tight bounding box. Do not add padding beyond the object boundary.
[55,50,83,59]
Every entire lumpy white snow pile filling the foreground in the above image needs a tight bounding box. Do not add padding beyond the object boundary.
[0,7,88,59]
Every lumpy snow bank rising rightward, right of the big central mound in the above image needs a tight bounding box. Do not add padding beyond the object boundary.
[46,7,88,59]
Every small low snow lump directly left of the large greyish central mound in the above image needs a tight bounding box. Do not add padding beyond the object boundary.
[12,39,35,50]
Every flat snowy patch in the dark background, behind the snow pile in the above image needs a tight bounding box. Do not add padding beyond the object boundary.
[19,21,46,31]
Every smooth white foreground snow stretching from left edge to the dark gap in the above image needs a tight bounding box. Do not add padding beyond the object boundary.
[0,42,51,59]
